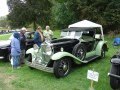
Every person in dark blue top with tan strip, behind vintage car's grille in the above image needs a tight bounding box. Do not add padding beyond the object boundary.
[34,26,44,47]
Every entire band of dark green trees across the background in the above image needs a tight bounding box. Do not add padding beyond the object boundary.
[8,0,120,32]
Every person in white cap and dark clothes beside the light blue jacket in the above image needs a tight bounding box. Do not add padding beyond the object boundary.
[20,27,27,65]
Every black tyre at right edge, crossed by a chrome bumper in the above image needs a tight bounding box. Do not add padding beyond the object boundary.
[110,65,120,89]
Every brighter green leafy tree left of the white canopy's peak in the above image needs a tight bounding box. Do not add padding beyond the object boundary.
[51,1,75,28]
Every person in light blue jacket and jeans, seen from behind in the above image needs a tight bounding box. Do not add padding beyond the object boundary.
[11,32,21,68]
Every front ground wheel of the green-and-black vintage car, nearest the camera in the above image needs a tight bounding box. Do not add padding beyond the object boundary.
[53,58,71,78]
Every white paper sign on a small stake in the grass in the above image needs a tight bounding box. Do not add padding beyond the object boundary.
[87,70,99,82]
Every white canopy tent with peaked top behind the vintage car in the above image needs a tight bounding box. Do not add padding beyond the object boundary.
[68,20,104,40]
